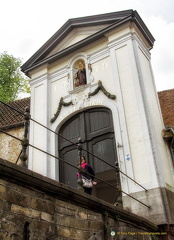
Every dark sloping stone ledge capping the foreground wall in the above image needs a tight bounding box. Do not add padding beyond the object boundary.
[0,158,158,231]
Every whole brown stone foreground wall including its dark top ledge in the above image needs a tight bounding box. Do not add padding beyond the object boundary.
[0,159,158,240]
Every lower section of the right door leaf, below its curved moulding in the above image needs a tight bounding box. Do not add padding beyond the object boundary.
[89,133,117,203]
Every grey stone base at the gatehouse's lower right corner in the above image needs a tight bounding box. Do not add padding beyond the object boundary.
[124,188,174,225]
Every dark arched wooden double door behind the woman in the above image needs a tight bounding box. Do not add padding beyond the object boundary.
[58,108,119,203]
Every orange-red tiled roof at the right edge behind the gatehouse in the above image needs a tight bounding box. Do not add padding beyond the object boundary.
[158,89,174,128]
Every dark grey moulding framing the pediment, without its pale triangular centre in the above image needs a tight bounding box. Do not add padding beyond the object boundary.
[21,10,154,74]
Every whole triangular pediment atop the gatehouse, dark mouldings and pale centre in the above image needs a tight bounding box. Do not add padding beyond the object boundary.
[21,10,154,74]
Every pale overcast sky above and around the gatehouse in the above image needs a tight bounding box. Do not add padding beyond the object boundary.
[0,0,174,91]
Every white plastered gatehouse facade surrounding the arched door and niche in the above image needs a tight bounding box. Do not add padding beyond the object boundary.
[22,10,174,224]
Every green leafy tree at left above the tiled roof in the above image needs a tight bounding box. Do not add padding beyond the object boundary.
[0,52,30,102]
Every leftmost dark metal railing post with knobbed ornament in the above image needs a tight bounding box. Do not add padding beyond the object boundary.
[20,107,31,167]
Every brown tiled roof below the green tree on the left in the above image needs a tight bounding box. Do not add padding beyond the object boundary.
[0,97,30,129]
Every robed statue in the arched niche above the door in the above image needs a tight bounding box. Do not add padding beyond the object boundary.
[74,60,87,87]
